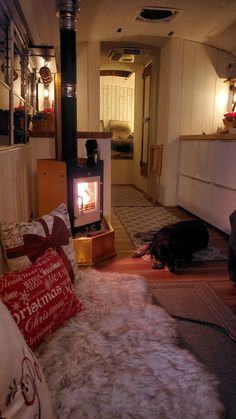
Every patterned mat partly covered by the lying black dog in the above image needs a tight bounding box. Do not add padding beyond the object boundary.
[114,206,227,261]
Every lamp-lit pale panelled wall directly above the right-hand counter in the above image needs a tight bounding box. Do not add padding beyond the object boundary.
[180,41,232,135]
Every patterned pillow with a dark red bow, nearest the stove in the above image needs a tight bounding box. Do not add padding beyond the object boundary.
[0,204,78,281]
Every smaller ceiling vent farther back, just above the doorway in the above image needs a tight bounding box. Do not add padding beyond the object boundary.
[107,47,149,63]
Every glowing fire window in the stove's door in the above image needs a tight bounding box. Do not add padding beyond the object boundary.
[73,176,100,227]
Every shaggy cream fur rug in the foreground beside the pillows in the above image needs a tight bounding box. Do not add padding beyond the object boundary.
[36,269,223,419]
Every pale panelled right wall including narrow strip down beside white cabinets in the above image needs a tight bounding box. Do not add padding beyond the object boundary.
[157,39,233,205]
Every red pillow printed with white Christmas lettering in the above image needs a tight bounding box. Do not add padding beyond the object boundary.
[0,249,83,347]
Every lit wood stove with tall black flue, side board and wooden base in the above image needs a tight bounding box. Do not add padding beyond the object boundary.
[38,0,115,265]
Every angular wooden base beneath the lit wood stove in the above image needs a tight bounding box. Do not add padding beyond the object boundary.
[73,222,116,265]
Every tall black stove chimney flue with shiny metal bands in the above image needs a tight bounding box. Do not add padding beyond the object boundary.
[56,0,79,166]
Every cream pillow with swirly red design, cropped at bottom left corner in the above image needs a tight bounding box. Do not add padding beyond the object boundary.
[0,301,54,419]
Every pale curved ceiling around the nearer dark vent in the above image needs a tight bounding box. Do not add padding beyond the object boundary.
[19,0,236,69]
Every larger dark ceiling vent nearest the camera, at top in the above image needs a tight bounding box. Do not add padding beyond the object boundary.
[135,7,183,23]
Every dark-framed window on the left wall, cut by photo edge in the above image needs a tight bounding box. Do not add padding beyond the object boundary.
[0,4,35,145]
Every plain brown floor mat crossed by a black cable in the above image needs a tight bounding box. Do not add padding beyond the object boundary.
[149,280,236,419]
